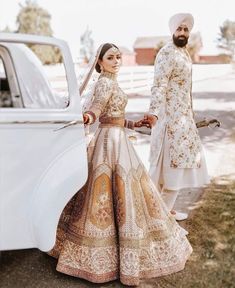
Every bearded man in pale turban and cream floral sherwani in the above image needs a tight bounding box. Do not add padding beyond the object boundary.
[145,13,209,220]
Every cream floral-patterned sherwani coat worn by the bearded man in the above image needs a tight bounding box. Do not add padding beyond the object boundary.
[150,42,207,189]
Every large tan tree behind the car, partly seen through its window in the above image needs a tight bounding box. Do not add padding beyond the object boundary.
[16,0,62,64]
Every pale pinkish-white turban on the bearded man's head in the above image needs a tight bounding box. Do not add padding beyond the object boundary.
[169,13,194,35]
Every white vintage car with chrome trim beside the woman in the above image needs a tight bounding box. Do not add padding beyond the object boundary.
[0,33,88,251]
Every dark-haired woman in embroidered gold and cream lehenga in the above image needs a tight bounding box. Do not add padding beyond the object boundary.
[51,43,192,285]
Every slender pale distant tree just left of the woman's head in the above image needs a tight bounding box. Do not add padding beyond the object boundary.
[80,27,94,63]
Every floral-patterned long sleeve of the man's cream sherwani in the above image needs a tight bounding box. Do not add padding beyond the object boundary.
[149,47,174,118]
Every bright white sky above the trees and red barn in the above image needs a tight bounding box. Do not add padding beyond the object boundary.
[0,0,235,58]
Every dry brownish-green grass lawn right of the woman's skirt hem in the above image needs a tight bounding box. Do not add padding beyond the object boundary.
[141,176,235,288]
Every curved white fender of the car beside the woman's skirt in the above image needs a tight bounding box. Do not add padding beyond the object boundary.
[29,139,88,251]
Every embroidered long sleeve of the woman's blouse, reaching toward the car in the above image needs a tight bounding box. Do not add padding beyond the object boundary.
[85,77,113,119]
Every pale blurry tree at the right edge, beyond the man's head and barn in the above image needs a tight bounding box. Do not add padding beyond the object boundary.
[217,20,235,59]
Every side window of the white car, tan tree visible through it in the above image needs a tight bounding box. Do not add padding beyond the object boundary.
[0,43,69,109]
